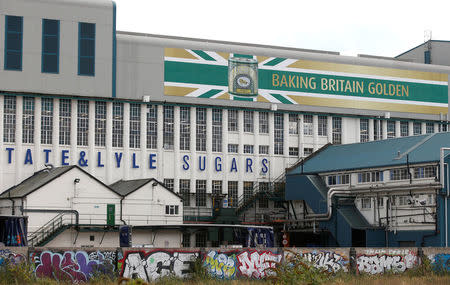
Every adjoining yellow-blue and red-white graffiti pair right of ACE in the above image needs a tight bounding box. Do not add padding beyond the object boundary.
[203,249,283,279]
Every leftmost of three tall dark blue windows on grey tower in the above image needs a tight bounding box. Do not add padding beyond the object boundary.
[5,16,23,70]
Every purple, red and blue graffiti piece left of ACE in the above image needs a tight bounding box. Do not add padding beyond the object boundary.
[30,250,116,283]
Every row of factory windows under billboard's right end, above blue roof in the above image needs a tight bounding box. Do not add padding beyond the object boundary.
[359,119,447,142]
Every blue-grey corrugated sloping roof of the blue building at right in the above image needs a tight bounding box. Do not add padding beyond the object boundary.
[287,133,450,174]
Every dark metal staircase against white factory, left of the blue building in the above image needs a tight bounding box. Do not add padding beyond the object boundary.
[236,172,286,215]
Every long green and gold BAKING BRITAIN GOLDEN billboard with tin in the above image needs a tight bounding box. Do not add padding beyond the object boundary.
[164,48,448,114]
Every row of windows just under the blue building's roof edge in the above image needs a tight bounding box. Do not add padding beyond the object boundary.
[327,166,436,185]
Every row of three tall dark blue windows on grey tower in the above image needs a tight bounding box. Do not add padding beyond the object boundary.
[4,15,95,76]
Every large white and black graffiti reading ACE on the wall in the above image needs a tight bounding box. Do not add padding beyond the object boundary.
[119,250,199,281]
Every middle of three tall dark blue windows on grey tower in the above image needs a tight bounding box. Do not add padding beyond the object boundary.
[41,19,59,73]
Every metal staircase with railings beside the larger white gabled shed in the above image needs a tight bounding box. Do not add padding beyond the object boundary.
[28,212,74,246]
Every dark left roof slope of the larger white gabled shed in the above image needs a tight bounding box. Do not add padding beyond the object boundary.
[0,165,76,198]
